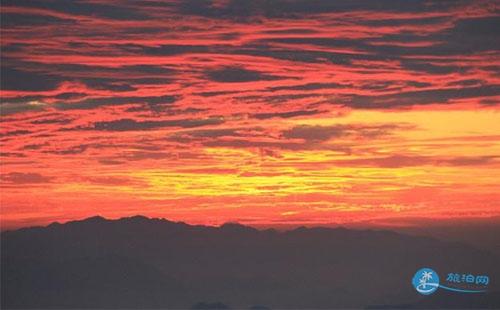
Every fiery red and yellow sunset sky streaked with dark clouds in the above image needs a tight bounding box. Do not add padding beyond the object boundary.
[0,0,500,228]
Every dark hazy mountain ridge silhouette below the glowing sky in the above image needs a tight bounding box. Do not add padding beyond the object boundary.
[1,216,500,309]
